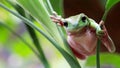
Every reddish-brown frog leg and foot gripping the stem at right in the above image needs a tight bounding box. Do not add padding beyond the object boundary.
[97,21,115,52]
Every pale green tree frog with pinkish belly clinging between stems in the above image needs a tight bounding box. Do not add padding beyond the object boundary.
[51,13,115,59]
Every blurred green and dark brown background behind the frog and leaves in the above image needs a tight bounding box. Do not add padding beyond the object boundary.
[0,0,120,68]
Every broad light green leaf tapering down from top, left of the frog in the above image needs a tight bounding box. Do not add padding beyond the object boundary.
[17,0,61,43]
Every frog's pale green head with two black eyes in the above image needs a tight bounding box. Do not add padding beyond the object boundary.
[64,13,90,32]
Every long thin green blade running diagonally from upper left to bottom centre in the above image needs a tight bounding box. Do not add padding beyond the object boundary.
[0,3,81,68]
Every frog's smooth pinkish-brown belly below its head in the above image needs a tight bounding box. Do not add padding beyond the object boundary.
[67,30,97,56]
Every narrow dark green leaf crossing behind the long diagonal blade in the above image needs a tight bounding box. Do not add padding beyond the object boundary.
[8,1,50,68]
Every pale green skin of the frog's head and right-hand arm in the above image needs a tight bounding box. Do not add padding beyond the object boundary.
[65,13,103,36]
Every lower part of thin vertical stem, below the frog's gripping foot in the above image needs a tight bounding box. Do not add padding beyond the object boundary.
[96,39,101,68]
